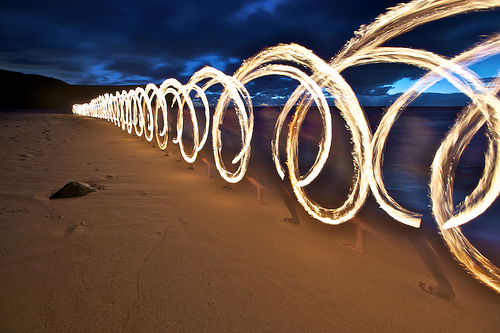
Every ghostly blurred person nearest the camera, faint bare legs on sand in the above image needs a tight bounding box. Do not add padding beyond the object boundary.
[344,116,455,300]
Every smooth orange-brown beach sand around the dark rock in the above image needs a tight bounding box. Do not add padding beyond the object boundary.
[0,113,500,332]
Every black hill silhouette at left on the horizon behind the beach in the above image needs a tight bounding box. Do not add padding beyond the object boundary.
[0,69,141,113]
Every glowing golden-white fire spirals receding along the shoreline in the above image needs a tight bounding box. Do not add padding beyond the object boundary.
[73,0,500,292]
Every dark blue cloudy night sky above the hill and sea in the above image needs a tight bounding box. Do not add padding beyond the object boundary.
[0,0,500,104]
